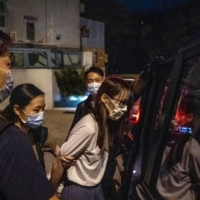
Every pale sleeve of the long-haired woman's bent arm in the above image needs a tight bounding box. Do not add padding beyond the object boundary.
[60,118,95,157]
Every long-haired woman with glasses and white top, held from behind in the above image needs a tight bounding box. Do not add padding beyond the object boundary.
[52,77,131,200]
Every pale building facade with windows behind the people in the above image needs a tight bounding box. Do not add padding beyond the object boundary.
[0,0,106,109]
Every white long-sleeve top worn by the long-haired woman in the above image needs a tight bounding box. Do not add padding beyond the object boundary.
[60,114,108,186]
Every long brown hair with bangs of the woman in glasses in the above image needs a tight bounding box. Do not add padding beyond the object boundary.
[93,77,131,152]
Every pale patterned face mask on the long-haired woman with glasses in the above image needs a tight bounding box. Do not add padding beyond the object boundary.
[105,97,127,121]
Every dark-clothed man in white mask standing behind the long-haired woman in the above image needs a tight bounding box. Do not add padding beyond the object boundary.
[66,66,149,200]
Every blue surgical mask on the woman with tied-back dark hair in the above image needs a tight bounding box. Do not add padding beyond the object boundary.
[19,110,44,129]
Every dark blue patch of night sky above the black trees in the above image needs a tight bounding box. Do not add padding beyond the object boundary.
[119,0,186,11]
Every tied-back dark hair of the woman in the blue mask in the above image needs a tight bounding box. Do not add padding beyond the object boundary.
[2,83,44,122]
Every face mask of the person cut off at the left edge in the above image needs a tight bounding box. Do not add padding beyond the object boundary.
[0,68,14,103]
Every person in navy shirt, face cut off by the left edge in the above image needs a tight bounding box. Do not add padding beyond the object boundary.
[0,31,58,200]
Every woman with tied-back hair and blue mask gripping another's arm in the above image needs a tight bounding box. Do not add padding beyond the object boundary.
[2,83,75,169]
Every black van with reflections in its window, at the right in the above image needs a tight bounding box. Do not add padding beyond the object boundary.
[121,37,200,200]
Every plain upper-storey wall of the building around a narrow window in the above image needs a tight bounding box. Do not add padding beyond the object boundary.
[7,0,80,49]
